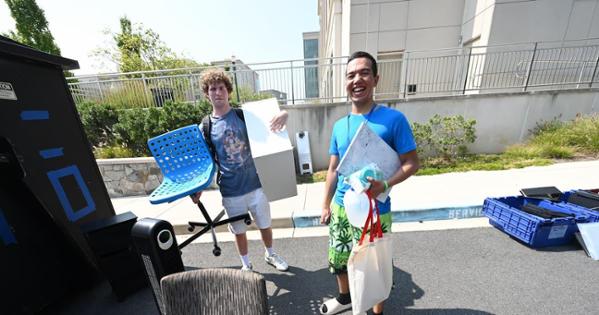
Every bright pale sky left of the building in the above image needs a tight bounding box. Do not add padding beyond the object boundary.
[0,0,319,75]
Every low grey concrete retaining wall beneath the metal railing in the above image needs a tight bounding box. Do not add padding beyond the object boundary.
[281,89,599,170]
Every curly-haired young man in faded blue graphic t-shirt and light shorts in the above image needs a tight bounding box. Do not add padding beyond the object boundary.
[192,69,289,271]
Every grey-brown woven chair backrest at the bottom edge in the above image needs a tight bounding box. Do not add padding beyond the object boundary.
[160,268,268,315]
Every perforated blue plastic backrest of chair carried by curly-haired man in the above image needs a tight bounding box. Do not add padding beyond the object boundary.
[148,124,214,183]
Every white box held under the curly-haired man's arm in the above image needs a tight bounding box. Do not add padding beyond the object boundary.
[242,98,297,201]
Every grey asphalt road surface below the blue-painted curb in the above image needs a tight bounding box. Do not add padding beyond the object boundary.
[60,226,599,315]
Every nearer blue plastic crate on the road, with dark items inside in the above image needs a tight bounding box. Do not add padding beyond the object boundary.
[483,196,578,248]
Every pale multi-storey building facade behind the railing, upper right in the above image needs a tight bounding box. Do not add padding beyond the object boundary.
[318,0,599,98]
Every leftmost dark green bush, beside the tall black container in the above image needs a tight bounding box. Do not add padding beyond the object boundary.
[77,102,118,147]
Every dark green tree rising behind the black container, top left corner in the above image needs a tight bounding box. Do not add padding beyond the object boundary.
[5,0,60,55]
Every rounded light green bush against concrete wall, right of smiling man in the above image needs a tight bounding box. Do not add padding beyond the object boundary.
[412,115,476,161]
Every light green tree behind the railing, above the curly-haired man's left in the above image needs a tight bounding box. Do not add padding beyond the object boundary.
[94,16,200,72]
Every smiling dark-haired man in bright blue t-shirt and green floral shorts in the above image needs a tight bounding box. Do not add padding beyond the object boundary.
[320,51,420,314]
